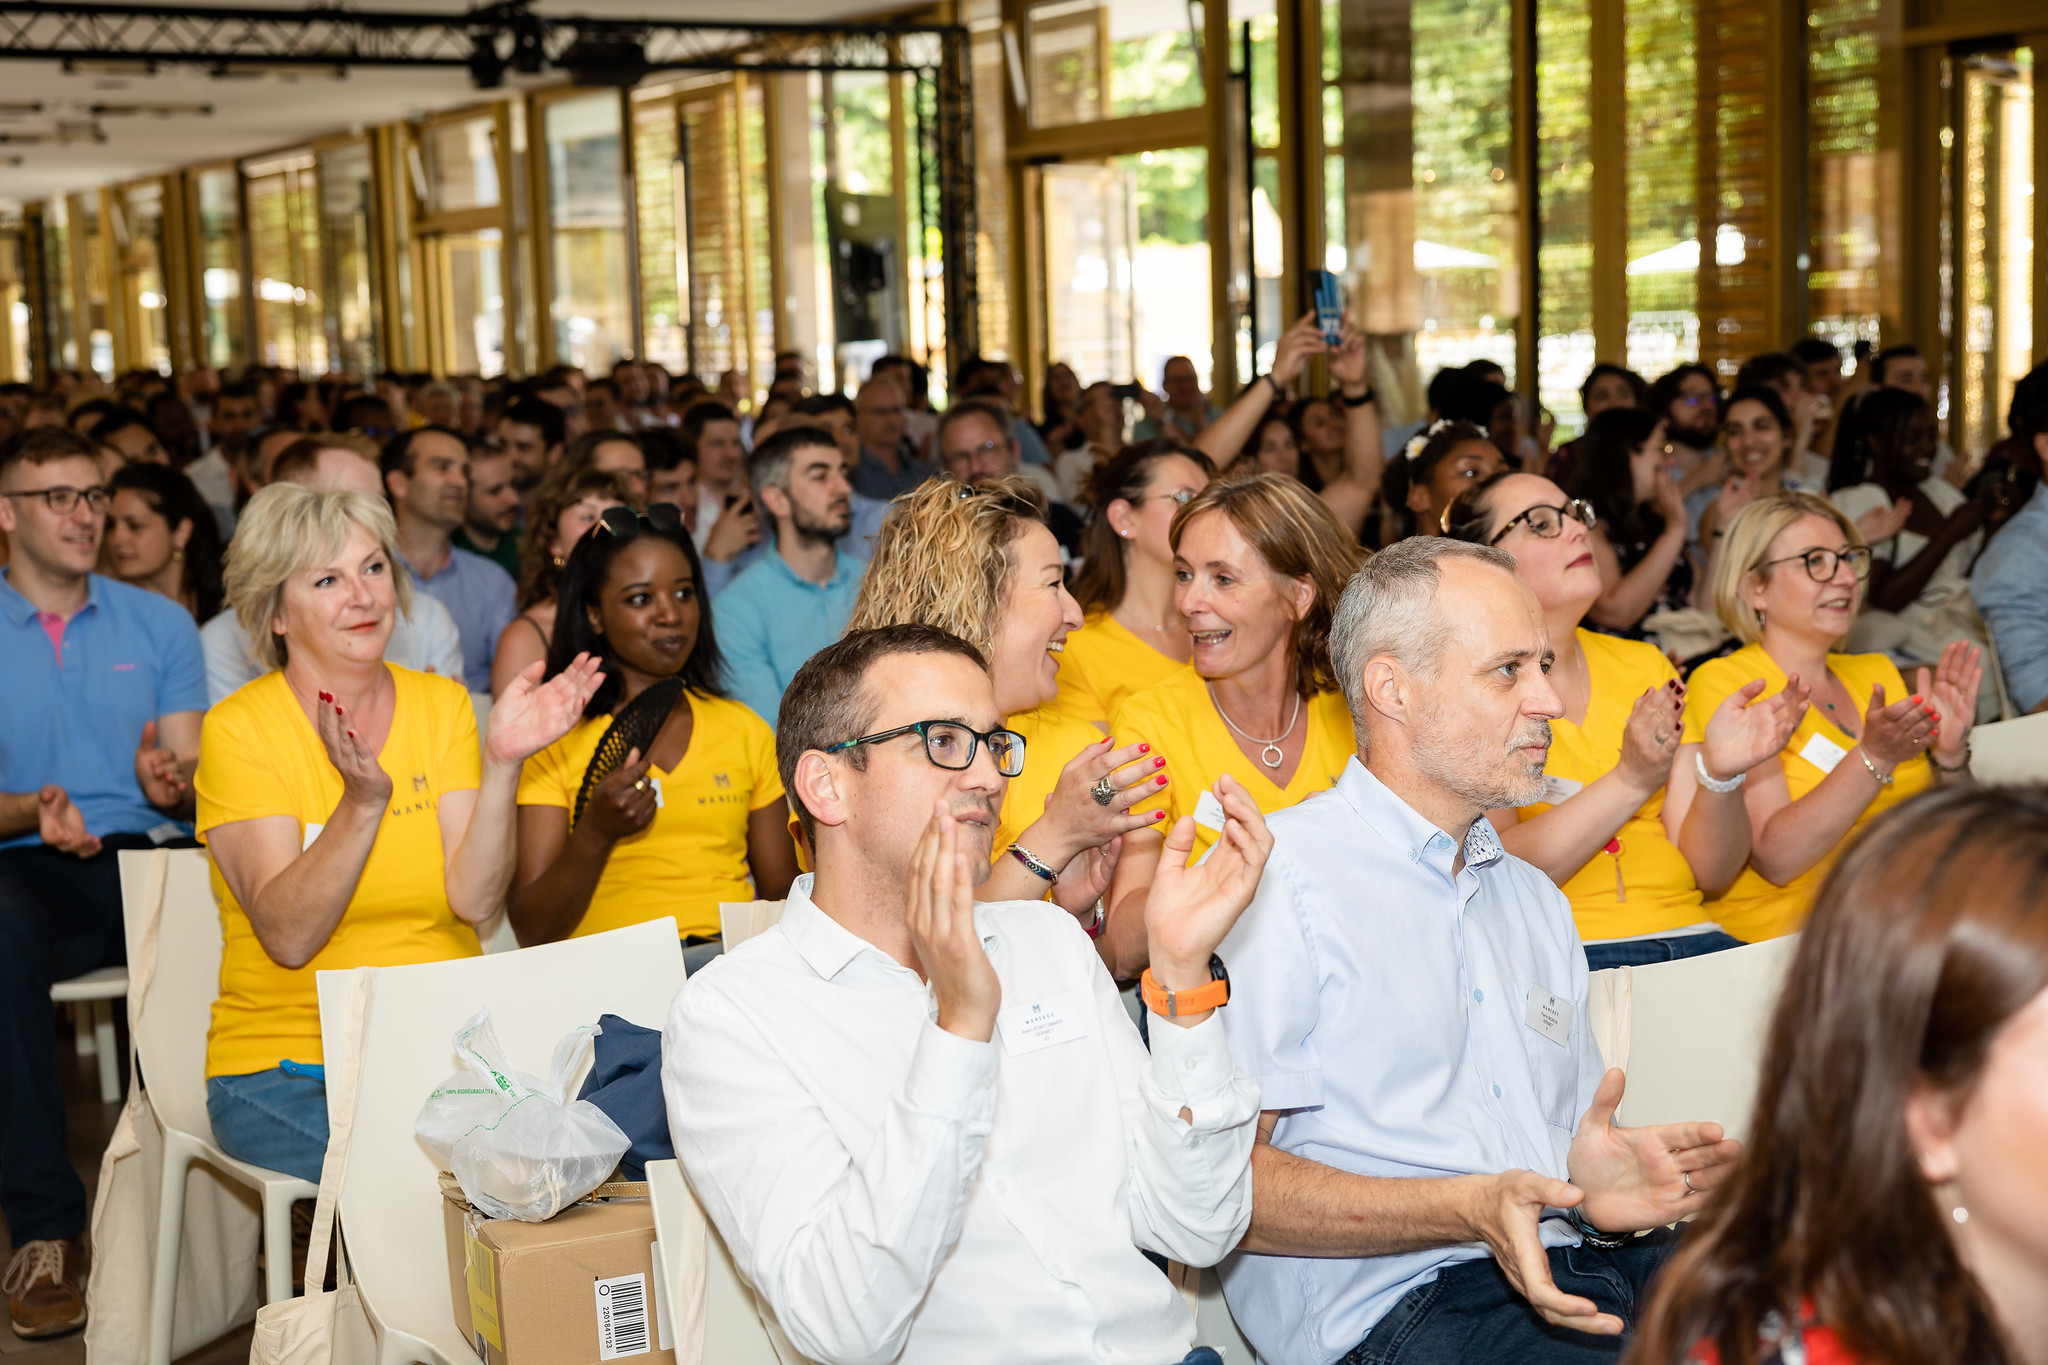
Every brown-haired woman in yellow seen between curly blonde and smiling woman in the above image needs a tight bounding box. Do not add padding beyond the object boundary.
[1056,436,1217,732]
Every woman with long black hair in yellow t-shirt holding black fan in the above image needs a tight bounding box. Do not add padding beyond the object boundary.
[512,503,797,970]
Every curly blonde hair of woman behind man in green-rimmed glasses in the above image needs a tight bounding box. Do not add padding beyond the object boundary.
[846,477,1044,655]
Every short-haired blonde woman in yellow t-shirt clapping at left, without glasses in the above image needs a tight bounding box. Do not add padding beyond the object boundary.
[193,483,602,1181]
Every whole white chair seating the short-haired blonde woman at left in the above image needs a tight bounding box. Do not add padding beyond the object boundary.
[121,849,319,1365]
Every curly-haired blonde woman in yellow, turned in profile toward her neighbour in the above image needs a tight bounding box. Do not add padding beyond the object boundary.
[846,477,1169,937]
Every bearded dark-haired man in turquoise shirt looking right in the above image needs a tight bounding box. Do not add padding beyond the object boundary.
[717,426,866,724]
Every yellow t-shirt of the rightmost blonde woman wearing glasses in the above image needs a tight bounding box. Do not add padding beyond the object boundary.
[1686,645,1933,943]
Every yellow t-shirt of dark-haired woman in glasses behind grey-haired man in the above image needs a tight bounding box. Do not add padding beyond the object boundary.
[1516,628,1710,943]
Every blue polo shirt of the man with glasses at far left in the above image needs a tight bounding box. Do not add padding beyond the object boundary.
[0,569,207,847]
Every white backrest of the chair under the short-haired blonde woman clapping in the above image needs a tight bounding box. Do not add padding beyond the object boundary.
[121,849,221,1142]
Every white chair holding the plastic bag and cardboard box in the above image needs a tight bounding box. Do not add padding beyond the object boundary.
[317,919,682,1365]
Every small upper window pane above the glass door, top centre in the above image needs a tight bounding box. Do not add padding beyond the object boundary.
[1024,0,1202,127]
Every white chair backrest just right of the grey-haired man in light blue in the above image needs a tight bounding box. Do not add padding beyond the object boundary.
[1587,935,1798,1138]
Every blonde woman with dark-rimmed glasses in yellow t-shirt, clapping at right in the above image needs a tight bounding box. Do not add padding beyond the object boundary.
[1686,493,1985,941]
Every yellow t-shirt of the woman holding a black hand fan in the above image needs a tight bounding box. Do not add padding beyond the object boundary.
[518,692,782,937]
